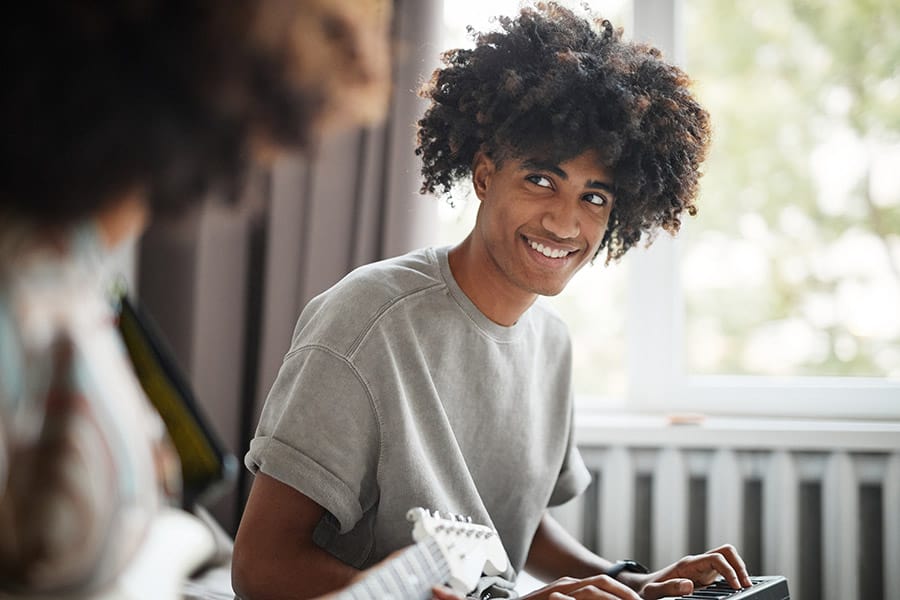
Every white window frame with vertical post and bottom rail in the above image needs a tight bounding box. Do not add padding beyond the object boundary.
[620,0,900,419]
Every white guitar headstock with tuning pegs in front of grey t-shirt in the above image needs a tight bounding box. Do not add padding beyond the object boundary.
[406,508,509,594]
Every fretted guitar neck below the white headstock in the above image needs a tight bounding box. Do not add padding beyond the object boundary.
[335,538,450,600]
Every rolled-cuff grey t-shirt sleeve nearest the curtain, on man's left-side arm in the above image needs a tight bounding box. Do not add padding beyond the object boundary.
[245,346,381,533]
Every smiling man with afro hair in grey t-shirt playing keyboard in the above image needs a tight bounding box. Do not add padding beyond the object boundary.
[233,3,751,600]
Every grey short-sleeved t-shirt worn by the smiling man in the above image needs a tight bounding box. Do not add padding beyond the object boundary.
[245,248,590,588]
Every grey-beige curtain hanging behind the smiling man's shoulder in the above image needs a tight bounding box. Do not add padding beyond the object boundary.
[137,0,442,533]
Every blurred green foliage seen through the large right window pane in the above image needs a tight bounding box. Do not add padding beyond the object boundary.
[683,0,900,378]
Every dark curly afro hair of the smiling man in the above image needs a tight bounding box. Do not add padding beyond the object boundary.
[416,3,710,262]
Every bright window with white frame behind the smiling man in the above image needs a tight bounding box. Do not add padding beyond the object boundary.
[443,0,900,418]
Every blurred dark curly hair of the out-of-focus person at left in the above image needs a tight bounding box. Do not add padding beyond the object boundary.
[0,0,390,224]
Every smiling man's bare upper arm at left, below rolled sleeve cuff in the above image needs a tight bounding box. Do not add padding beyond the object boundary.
[231,472,359,600]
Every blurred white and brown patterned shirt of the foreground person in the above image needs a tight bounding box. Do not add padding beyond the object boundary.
[0,219,180,592]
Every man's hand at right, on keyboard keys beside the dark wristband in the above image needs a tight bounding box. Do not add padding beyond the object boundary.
[619,544,752,600]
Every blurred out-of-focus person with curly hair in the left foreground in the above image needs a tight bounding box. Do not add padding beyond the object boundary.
[0,0,460,600]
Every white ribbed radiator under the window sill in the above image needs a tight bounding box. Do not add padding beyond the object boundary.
[554,417,900,600]
